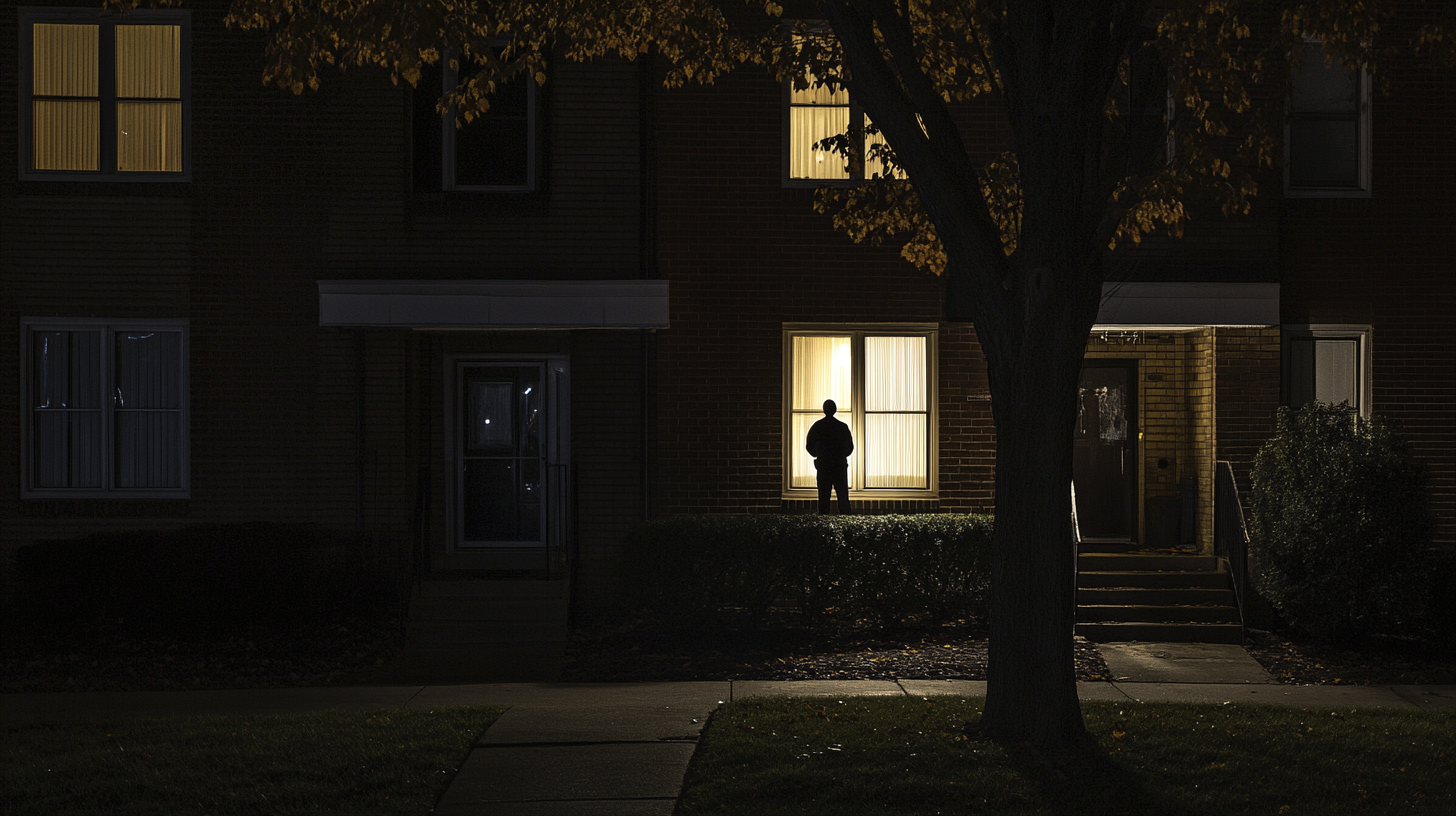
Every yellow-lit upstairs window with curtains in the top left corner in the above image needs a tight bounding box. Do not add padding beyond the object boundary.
[19,7,191,181]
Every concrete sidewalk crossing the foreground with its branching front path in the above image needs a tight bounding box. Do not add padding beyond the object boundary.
[8,680,1456,816]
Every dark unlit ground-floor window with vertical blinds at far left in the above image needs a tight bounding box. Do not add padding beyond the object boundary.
[25,321,188,495]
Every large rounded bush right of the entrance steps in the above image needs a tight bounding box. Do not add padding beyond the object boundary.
[1249,404,1431,637]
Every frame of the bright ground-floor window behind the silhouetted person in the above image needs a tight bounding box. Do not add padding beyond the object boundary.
[780,323,941,501]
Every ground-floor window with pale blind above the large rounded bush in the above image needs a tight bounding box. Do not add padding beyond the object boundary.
[1284,325,1370,417]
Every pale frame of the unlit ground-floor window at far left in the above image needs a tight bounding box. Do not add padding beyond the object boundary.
[20,318,192,498]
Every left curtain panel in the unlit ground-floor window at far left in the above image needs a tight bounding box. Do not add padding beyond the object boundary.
[31,331,102,488]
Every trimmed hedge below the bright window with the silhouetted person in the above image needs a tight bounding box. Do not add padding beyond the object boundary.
[626,513,992,625]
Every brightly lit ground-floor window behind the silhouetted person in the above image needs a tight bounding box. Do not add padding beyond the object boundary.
[785,326,935,495]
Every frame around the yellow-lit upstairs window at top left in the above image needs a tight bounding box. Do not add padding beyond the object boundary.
[16,6,192,182]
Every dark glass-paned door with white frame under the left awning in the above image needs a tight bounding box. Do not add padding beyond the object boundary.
[454,360,569,571]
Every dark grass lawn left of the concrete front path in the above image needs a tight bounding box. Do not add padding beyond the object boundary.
[0,707,505,816]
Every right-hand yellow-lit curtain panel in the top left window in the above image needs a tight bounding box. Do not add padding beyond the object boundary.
[116,25,182,172]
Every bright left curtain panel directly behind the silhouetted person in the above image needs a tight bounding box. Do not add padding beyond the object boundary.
[789,337,859,487]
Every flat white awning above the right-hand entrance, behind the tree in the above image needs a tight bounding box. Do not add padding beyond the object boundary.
[1096,283,1278,328]
